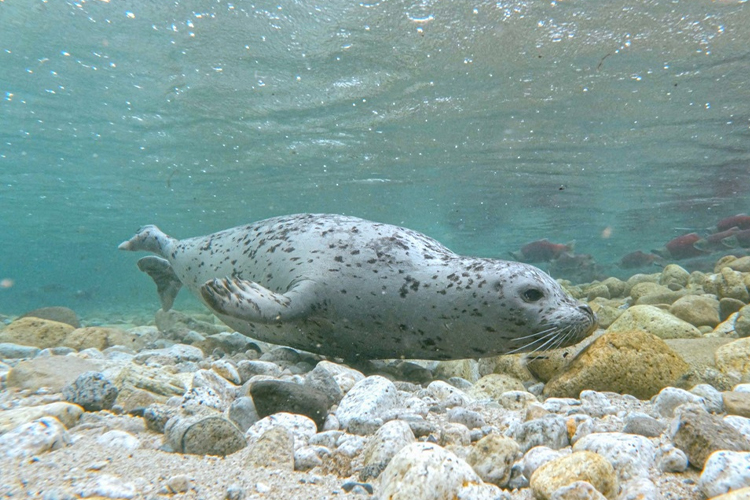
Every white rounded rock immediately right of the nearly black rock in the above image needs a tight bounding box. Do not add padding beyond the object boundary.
[335,375,402,429]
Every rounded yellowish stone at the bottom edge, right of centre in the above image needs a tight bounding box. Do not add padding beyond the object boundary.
[529,451,619,500]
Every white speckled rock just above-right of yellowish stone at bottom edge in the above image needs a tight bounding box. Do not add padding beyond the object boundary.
[573,432,656,482]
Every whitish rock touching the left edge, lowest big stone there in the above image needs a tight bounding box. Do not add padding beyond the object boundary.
[0,417,72,457]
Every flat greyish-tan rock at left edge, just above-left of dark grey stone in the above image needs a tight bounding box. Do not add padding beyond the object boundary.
[8,356,97,392]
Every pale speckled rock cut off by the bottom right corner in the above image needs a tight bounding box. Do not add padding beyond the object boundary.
[698,451,750,498]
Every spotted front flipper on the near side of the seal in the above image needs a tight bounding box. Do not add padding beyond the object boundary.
[201,278,315,323]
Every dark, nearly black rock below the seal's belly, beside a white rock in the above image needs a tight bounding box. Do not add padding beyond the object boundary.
[250,380,330,430]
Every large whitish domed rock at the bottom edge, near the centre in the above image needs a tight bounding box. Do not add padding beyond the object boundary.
[378,443,500,500]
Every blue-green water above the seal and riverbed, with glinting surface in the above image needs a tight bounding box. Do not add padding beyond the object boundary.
[0,0,750,314]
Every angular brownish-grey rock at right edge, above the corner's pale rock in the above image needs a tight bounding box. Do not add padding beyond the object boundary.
[669,405,750,469]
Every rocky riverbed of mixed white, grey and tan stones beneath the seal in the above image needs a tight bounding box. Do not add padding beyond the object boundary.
[0,256,750,500]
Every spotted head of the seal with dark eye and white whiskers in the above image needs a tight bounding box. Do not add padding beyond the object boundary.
[495,262,597,353]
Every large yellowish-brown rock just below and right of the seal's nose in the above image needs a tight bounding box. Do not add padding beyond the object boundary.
[544,330,688,399]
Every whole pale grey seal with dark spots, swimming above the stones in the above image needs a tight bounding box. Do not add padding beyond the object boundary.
[119,214,596,360]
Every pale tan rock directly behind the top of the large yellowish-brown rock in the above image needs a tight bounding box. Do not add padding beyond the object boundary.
[607,305,702,339]
